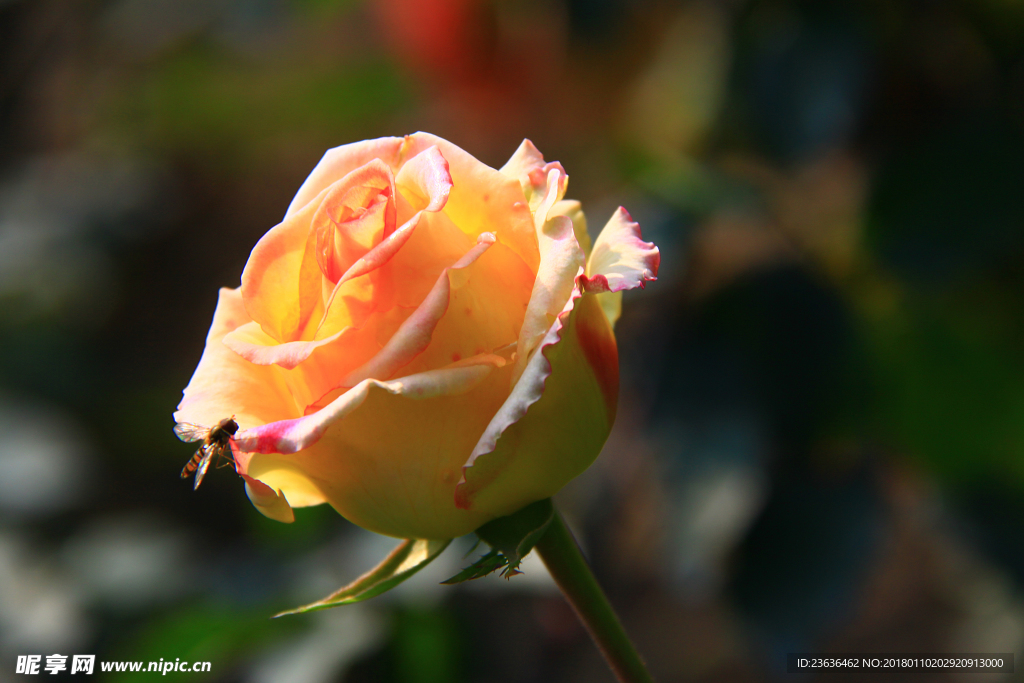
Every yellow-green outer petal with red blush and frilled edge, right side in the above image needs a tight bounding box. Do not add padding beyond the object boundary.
[456,289,618,515]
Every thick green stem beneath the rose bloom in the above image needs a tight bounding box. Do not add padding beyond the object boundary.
[537,510,654,683]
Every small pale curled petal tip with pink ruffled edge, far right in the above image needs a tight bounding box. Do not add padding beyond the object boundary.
[582,207,662,293]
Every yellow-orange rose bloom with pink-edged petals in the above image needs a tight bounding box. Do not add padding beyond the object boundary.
[174,133,659,539]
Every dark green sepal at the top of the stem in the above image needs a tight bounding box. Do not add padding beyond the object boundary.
[443,498,555,584]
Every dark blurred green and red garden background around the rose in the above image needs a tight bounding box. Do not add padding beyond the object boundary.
[0,0,1024,683]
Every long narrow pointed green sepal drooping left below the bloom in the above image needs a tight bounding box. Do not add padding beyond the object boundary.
[274,539,452,618]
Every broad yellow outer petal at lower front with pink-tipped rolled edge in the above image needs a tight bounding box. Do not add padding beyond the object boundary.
[236,357,509,539]
